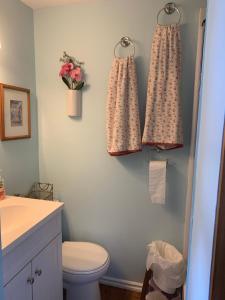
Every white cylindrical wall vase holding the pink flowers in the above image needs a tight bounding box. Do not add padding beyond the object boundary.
[67,90,82,117]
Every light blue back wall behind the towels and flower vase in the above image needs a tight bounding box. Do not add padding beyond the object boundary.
[35,0,205,281]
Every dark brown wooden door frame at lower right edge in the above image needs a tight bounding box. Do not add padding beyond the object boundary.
[210,123,225,300]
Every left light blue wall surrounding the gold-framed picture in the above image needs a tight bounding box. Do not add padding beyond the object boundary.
[0,0,38,194]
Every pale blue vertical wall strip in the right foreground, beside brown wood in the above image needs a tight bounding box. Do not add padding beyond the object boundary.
[187,0,225,300]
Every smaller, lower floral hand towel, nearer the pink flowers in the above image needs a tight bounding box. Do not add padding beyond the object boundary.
[106,56,141,156]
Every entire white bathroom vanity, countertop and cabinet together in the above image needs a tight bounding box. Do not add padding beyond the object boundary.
[0,196,63,290]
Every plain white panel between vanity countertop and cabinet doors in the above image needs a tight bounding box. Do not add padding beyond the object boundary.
[3,213,61,286]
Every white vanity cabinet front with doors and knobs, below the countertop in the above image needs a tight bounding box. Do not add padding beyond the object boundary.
[3,199,63,300]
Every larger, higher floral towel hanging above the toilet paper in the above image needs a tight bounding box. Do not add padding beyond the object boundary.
[142,25,183,150]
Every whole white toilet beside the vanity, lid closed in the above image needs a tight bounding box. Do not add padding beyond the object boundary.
[62,242,110,300]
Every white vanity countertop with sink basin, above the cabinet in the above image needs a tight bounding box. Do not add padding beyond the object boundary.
[0,196,63,255]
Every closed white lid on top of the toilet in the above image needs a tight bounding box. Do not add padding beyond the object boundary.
[62,242,109,273]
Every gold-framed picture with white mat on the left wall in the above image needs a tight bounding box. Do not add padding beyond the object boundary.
[0,83,31,141]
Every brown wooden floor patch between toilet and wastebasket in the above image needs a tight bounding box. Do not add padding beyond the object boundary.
[100,284,141,300]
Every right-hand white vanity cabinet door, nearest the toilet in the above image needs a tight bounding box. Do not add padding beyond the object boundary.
[32,235,62,300]
